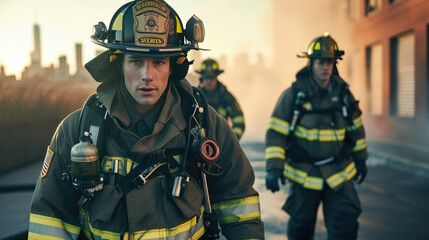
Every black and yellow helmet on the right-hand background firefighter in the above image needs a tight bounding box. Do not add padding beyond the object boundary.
[298,33,344,60]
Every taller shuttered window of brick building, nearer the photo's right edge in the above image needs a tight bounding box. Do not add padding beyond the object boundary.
[390,33,416,117]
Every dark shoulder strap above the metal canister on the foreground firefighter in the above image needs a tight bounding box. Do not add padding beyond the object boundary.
[79,93,109,156]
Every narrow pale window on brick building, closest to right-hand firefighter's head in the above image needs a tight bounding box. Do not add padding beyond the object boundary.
[366,44,383,116]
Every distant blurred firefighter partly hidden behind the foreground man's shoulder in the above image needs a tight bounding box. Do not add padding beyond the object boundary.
[196,58,245,139]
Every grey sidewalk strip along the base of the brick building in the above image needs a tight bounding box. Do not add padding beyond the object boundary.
[367,140,429,176]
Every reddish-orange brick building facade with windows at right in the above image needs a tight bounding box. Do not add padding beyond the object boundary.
[351,0,429,146]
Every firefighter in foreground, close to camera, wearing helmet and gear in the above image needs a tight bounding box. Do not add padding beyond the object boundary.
[29,0,264,239]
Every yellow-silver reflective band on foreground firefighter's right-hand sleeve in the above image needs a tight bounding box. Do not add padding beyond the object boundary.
[213,196,261,224]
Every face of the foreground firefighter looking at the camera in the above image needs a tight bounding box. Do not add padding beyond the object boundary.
[122,54,171,113]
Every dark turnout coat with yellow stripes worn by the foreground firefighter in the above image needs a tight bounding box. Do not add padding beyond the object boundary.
[29,53,264,240]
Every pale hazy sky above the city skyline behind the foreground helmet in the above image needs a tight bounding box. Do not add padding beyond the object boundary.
[0,0,272,76]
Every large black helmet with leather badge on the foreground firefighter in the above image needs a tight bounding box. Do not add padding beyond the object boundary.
[91,0,204,57]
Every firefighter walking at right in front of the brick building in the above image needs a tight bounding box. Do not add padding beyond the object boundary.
[265,33,368,240]
